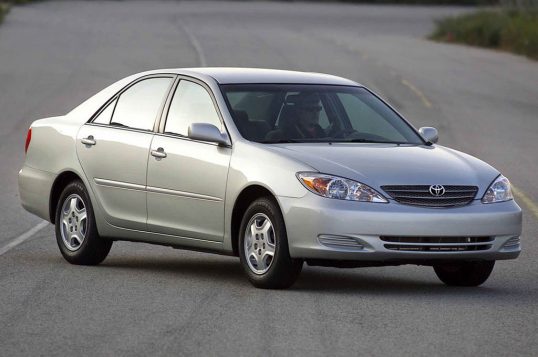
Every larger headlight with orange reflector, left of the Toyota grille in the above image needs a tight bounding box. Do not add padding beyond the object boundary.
[297,172,388,203]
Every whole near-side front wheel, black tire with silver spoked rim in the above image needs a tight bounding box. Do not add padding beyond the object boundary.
[239,198,303,289]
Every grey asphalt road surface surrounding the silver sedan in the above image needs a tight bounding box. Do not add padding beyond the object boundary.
[0,1,538,356]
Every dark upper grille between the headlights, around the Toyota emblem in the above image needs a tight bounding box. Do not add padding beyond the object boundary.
[381,185,478,207]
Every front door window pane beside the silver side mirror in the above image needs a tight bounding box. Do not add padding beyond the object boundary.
[164,80,222,136]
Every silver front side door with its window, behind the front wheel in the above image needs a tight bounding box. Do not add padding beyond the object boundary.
[147,80,231,241]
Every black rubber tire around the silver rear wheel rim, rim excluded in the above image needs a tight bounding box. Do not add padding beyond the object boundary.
[55,180,112,265]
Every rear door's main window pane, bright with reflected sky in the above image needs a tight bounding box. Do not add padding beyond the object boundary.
[110,78,172,130]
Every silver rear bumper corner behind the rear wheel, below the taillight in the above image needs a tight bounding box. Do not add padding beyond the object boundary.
[19,165,56,222]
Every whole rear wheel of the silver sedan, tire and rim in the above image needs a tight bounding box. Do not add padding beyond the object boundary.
[55,180,112,265]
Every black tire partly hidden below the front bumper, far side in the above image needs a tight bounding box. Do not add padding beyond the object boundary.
[433,260,495,286]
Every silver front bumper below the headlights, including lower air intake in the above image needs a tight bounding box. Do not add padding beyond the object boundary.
[278,193,522,262]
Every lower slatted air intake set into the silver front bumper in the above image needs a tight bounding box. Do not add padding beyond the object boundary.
[379,236,493,252]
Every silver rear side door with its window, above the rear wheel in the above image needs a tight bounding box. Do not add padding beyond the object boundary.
[77,76,174,230]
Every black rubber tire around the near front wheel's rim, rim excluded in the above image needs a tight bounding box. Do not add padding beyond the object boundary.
[239,197,303,289]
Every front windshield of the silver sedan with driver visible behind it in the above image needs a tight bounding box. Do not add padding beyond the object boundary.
[221,84,424,145]
